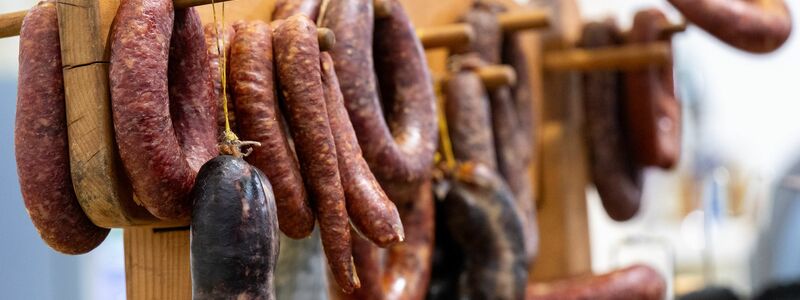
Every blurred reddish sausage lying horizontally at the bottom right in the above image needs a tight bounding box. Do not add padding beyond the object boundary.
[525,265,667,300]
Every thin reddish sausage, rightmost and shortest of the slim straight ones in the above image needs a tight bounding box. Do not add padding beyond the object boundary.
[320,53,404,247]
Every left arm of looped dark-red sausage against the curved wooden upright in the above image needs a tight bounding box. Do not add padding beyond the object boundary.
[109,0,196,220]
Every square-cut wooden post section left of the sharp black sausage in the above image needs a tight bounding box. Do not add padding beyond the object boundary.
[124,227,192,300]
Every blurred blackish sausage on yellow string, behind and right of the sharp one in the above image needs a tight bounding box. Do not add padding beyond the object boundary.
[443,163,528,299]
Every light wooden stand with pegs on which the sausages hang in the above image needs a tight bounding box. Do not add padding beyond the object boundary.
[0,0,669,300]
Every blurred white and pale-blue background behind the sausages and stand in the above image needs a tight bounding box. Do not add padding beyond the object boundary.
[0,0,800,299]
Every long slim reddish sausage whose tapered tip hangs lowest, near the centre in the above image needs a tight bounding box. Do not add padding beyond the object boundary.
[273,15,360,293]
